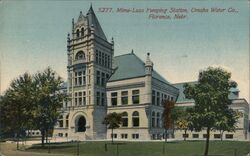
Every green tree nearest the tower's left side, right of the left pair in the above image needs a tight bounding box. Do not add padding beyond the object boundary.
[34,67,66,146]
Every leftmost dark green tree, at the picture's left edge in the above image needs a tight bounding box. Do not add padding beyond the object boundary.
[0,73,35,149]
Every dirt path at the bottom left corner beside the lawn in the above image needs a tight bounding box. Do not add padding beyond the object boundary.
[0,143,67,156]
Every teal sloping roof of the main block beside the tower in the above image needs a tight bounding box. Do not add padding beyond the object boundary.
[109,52,170,84]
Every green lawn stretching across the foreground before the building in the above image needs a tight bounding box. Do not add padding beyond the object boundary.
[25,141,250,156]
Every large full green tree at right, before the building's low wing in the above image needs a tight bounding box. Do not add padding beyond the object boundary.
[184,67,237,156]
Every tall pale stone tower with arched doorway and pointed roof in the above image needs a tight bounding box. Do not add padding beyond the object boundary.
[66,6,114,139]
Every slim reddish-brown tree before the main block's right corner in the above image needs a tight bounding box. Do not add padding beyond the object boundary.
[162,100,175,142]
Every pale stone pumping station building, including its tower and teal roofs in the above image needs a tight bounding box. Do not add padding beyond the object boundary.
[53,6,248,140]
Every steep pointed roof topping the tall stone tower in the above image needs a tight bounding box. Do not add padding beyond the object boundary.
[86,5,107,40]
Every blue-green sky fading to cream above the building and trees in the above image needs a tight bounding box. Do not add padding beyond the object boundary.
[0,0,250,101]
